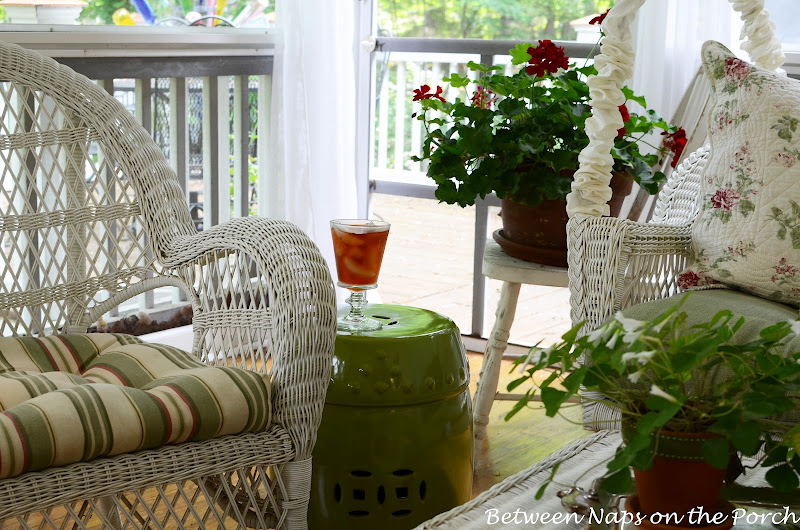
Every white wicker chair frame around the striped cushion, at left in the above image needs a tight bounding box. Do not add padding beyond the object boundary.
[0,38,336,528]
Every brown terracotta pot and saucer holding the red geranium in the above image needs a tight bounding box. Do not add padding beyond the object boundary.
[492,174,633,267]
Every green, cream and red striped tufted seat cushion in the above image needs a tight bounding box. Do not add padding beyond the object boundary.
[0,334,270,478]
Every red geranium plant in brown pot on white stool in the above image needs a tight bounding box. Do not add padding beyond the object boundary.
[413,34,686,266]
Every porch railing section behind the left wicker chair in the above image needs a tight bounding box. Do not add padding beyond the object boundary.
[0,25,273,326]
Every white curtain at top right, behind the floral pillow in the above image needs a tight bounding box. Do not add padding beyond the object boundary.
[629,0,740,120]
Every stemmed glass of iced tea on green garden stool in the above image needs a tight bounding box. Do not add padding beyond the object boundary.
[331,219,389,331]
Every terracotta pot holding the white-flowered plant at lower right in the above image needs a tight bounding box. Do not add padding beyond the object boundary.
[634,431,725,528]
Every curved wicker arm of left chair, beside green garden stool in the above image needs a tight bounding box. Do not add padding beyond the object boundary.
[162,217,336,460]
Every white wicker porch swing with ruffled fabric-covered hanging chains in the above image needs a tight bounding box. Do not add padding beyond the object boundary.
[567,0,783,425]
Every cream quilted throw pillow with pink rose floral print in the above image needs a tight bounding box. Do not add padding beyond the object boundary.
[678,41,800,306]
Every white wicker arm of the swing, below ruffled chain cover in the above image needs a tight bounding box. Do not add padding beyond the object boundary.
[567,216,691,331]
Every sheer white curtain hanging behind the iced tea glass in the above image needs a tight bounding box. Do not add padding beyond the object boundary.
[268,0,357,279]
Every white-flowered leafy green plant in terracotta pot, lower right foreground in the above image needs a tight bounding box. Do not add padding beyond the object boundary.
[507,300,800,528]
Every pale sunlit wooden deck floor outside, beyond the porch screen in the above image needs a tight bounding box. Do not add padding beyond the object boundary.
[370,194,570,345]
